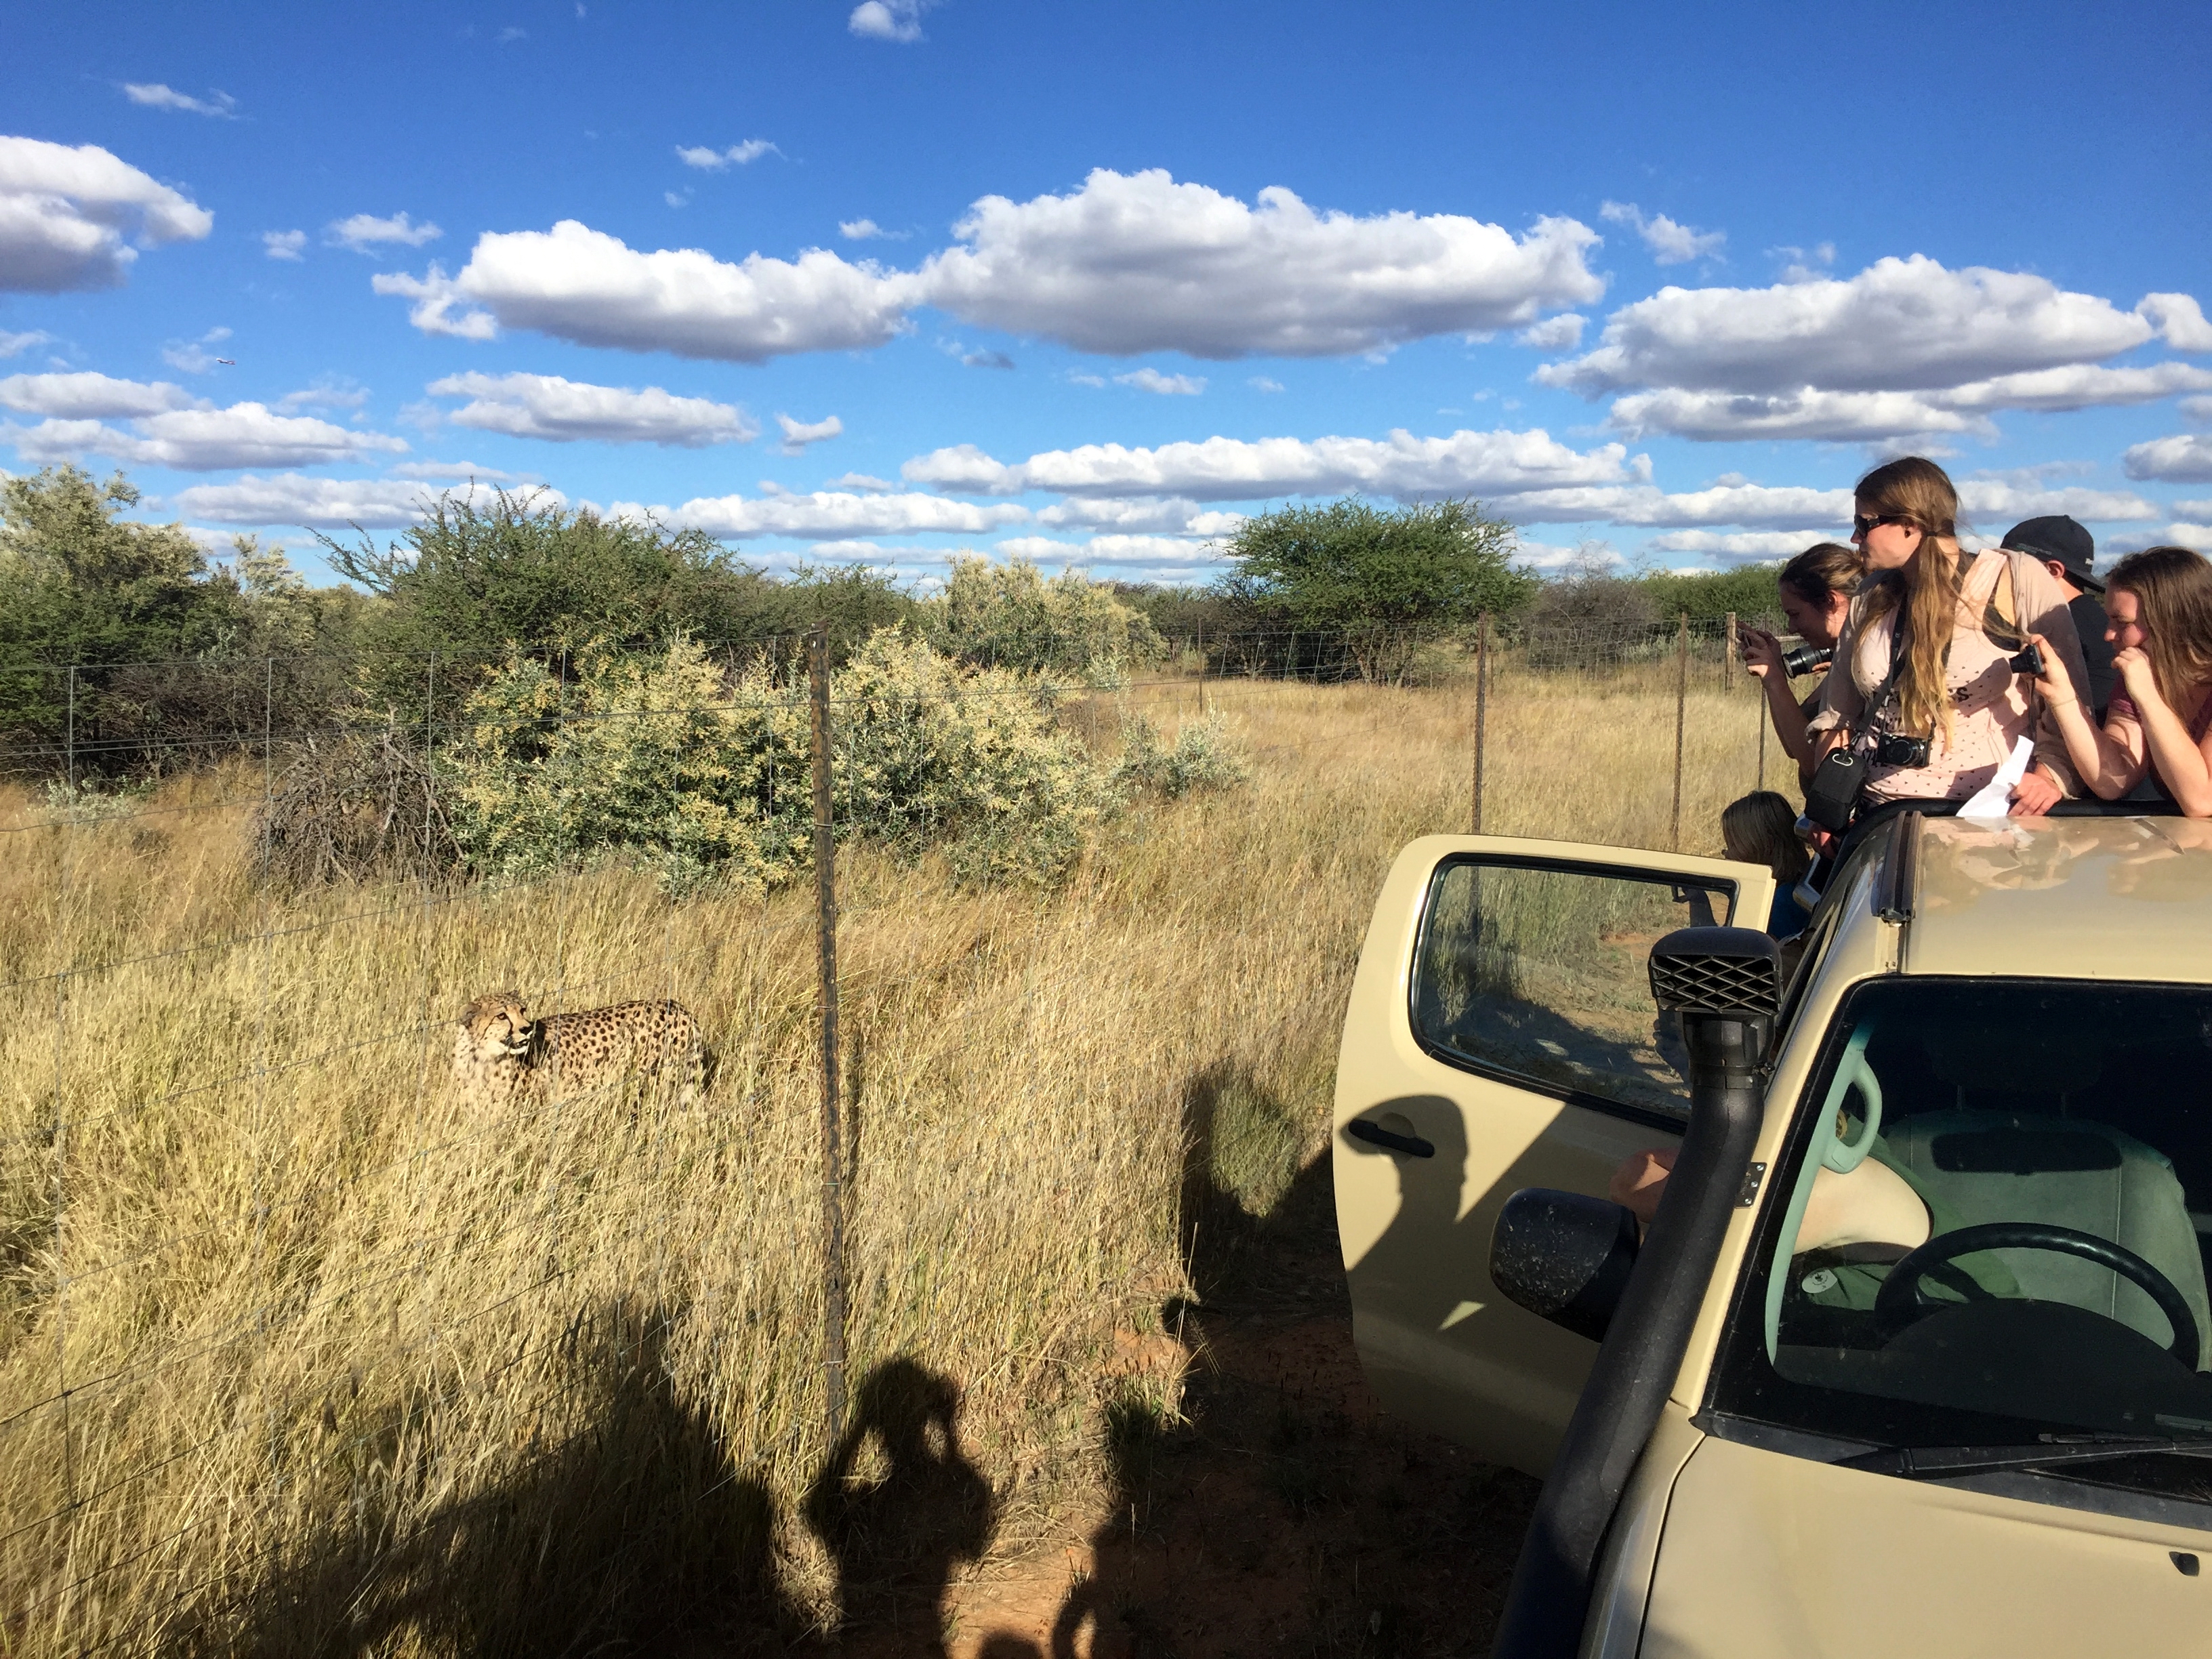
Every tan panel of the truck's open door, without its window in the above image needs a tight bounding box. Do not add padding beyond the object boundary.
[1332,836,1774,1475]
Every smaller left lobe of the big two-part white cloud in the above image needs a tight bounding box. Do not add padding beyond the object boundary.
[374,219,914,363]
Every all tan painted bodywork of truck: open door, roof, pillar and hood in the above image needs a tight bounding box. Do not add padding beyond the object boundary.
[1334,819,2212,1659]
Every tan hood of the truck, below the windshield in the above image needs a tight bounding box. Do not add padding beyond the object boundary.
[1637,1438,2212,1659]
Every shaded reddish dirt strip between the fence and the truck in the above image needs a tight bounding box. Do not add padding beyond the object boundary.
[752,1159,1535,1659]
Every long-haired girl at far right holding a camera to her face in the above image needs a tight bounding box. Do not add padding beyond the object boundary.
[2039,546,2212,819]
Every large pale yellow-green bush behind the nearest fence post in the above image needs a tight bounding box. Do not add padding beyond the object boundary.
[441,628,1120,894]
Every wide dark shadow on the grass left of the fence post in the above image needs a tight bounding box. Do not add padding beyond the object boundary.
[216,1298,803,1657]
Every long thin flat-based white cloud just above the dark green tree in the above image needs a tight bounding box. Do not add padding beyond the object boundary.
[900,429,1639,502]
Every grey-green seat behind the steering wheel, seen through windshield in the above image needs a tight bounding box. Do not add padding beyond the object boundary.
[1883,1111,2212,1369]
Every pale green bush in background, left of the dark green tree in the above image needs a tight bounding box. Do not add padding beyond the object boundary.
[920,553,1168,686]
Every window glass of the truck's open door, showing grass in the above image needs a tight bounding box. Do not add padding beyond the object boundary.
[1414,858,1736,1120]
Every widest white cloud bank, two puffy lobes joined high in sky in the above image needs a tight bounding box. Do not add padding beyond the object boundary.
[371,168,1603,365]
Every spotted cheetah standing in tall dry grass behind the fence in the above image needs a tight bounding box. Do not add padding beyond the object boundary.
[453,991,708,1106]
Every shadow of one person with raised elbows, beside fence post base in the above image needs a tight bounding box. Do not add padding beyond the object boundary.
[805,1358,998,1654]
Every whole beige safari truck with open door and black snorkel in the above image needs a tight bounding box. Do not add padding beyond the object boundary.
[1334,812,2212,1659]
